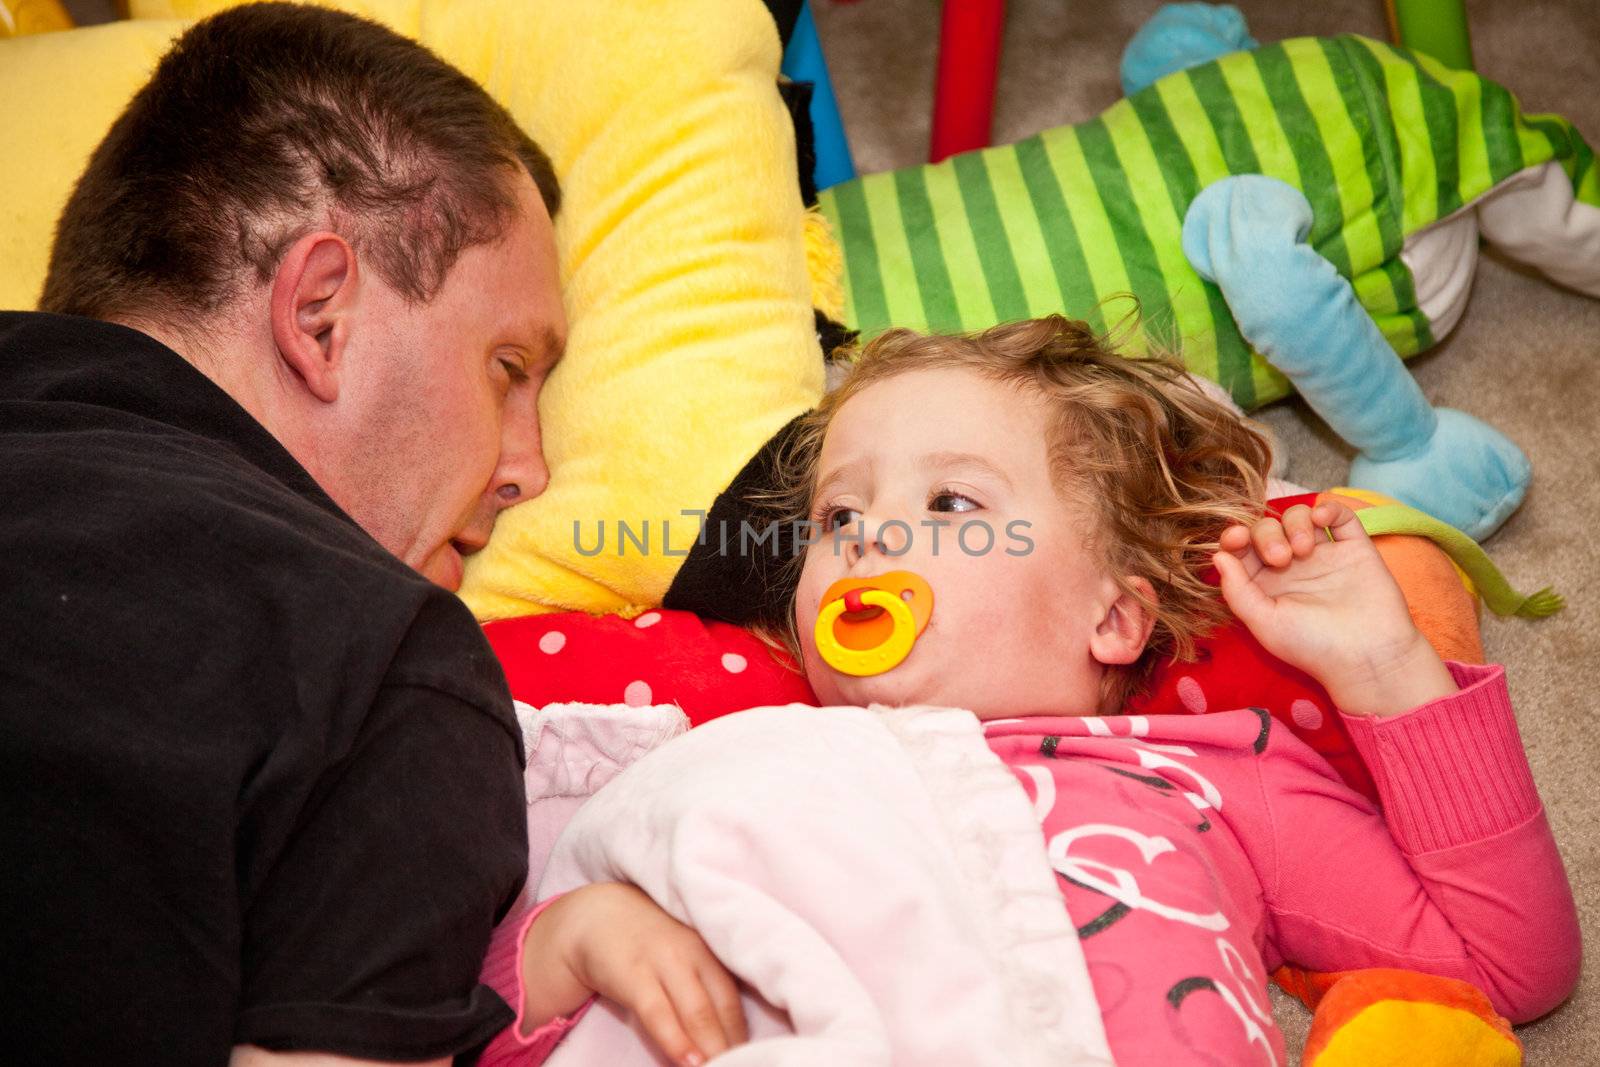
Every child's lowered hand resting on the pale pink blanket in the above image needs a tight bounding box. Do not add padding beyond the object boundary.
[522,883,746,1067]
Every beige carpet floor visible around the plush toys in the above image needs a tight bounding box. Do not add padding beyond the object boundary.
[813,0,1600,1065]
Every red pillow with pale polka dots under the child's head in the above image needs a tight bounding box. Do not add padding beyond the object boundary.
[483,496,1378,800]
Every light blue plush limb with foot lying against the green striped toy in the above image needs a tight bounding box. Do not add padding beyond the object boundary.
[1184,174,1531,541]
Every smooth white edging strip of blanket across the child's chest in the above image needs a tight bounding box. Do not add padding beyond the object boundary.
[869,705,1112,1067]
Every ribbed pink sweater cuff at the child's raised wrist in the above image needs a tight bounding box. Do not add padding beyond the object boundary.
[1339,662,1539,856]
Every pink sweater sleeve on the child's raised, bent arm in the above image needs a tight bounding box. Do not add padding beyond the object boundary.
[1258,664,1579,1022]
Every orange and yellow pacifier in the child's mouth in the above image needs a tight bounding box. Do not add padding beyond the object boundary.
[816,571,933,677]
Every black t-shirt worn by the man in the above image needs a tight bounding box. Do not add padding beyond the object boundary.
[0,314,526,1065]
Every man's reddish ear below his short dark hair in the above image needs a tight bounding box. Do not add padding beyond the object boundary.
[270,230,357,403]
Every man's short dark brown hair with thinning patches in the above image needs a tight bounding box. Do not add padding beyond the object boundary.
[40,3,560,326]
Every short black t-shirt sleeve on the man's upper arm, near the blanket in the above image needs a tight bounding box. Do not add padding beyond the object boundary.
[235,683,526,1061]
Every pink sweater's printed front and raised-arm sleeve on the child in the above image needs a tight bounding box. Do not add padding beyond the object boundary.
[987,664,1581,1067]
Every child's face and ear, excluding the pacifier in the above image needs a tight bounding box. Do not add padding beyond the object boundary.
[795,368,1147,718]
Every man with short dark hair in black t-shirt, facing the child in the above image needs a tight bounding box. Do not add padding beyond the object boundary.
[0,5,731,1064]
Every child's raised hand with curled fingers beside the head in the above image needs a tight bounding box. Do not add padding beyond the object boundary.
[1213,501,1456,715]
